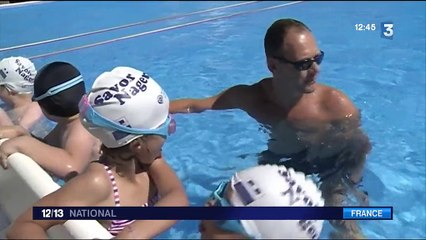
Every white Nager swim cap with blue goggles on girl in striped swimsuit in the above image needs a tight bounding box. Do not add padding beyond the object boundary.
[80,67,170,148]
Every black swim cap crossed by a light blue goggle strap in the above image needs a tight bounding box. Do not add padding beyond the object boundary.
[34,62,86,117]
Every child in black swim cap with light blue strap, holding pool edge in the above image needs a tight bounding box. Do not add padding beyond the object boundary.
[0,62,100,184]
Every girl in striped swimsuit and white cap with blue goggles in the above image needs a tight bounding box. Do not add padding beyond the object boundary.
[7,67,188,239]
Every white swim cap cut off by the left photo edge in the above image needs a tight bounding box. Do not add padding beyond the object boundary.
[0,57,37,94]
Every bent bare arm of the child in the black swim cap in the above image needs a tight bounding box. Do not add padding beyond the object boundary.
[0,132,94,178]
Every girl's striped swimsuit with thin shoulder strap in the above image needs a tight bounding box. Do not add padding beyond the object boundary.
[104,166,159,236]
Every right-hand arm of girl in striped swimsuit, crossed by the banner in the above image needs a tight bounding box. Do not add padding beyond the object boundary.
[117,158,189,239]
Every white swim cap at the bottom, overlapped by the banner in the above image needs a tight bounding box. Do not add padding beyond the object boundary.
[228,165,324,239]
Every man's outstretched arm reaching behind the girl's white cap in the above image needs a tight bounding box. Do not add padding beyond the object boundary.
[169,85,251,114]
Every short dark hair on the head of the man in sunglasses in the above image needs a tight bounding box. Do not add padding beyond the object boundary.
[263,18,311,57]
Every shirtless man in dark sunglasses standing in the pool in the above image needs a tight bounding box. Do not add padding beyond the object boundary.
[170,19,371,238]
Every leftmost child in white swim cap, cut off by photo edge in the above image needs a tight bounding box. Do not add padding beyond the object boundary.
[0,57,43,130]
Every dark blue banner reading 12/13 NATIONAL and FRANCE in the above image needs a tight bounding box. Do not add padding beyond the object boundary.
[33,207,393,220]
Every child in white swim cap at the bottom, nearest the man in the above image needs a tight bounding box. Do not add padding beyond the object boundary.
[199,165,324,239]
